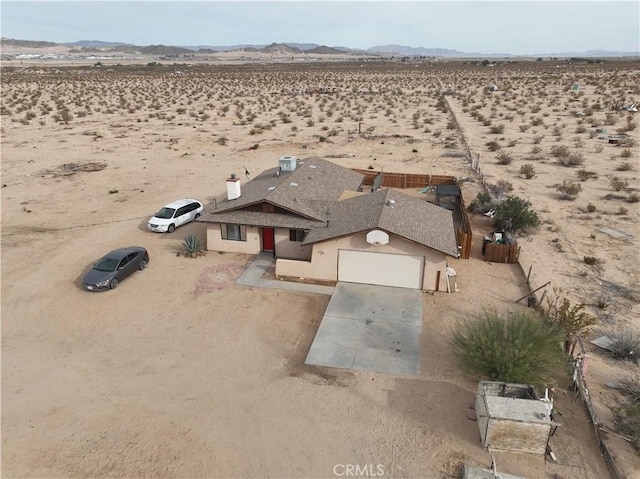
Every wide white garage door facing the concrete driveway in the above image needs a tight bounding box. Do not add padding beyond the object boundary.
[338,250,424,289]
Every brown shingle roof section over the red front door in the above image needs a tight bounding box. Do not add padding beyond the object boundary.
[200,158,364,223]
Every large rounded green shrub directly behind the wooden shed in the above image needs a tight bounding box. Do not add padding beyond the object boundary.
[453,310,563,384]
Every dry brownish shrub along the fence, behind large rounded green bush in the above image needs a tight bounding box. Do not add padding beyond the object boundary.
[538,288,596,344]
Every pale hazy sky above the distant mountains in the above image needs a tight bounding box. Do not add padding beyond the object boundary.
[0,0,640,55]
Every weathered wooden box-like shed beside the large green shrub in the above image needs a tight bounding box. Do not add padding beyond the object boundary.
[476,381,557,454]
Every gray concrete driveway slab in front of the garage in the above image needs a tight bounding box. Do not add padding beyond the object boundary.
[305,282,422,376]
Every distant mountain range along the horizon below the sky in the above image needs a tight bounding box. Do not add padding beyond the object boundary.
[0,38,640,58]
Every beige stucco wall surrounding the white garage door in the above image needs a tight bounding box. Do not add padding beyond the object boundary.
[276,232,447,291]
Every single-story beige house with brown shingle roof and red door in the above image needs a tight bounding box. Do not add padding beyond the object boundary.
[197,156,459,291]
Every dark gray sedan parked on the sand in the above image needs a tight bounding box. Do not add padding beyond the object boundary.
[82,246,149,291]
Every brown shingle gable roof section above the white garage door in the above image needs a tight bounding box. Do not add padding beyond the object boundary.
[303,188,458,256]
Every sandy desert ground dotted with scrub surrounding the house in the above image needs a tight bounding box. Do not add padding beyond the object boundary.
[0,57,640,479]
